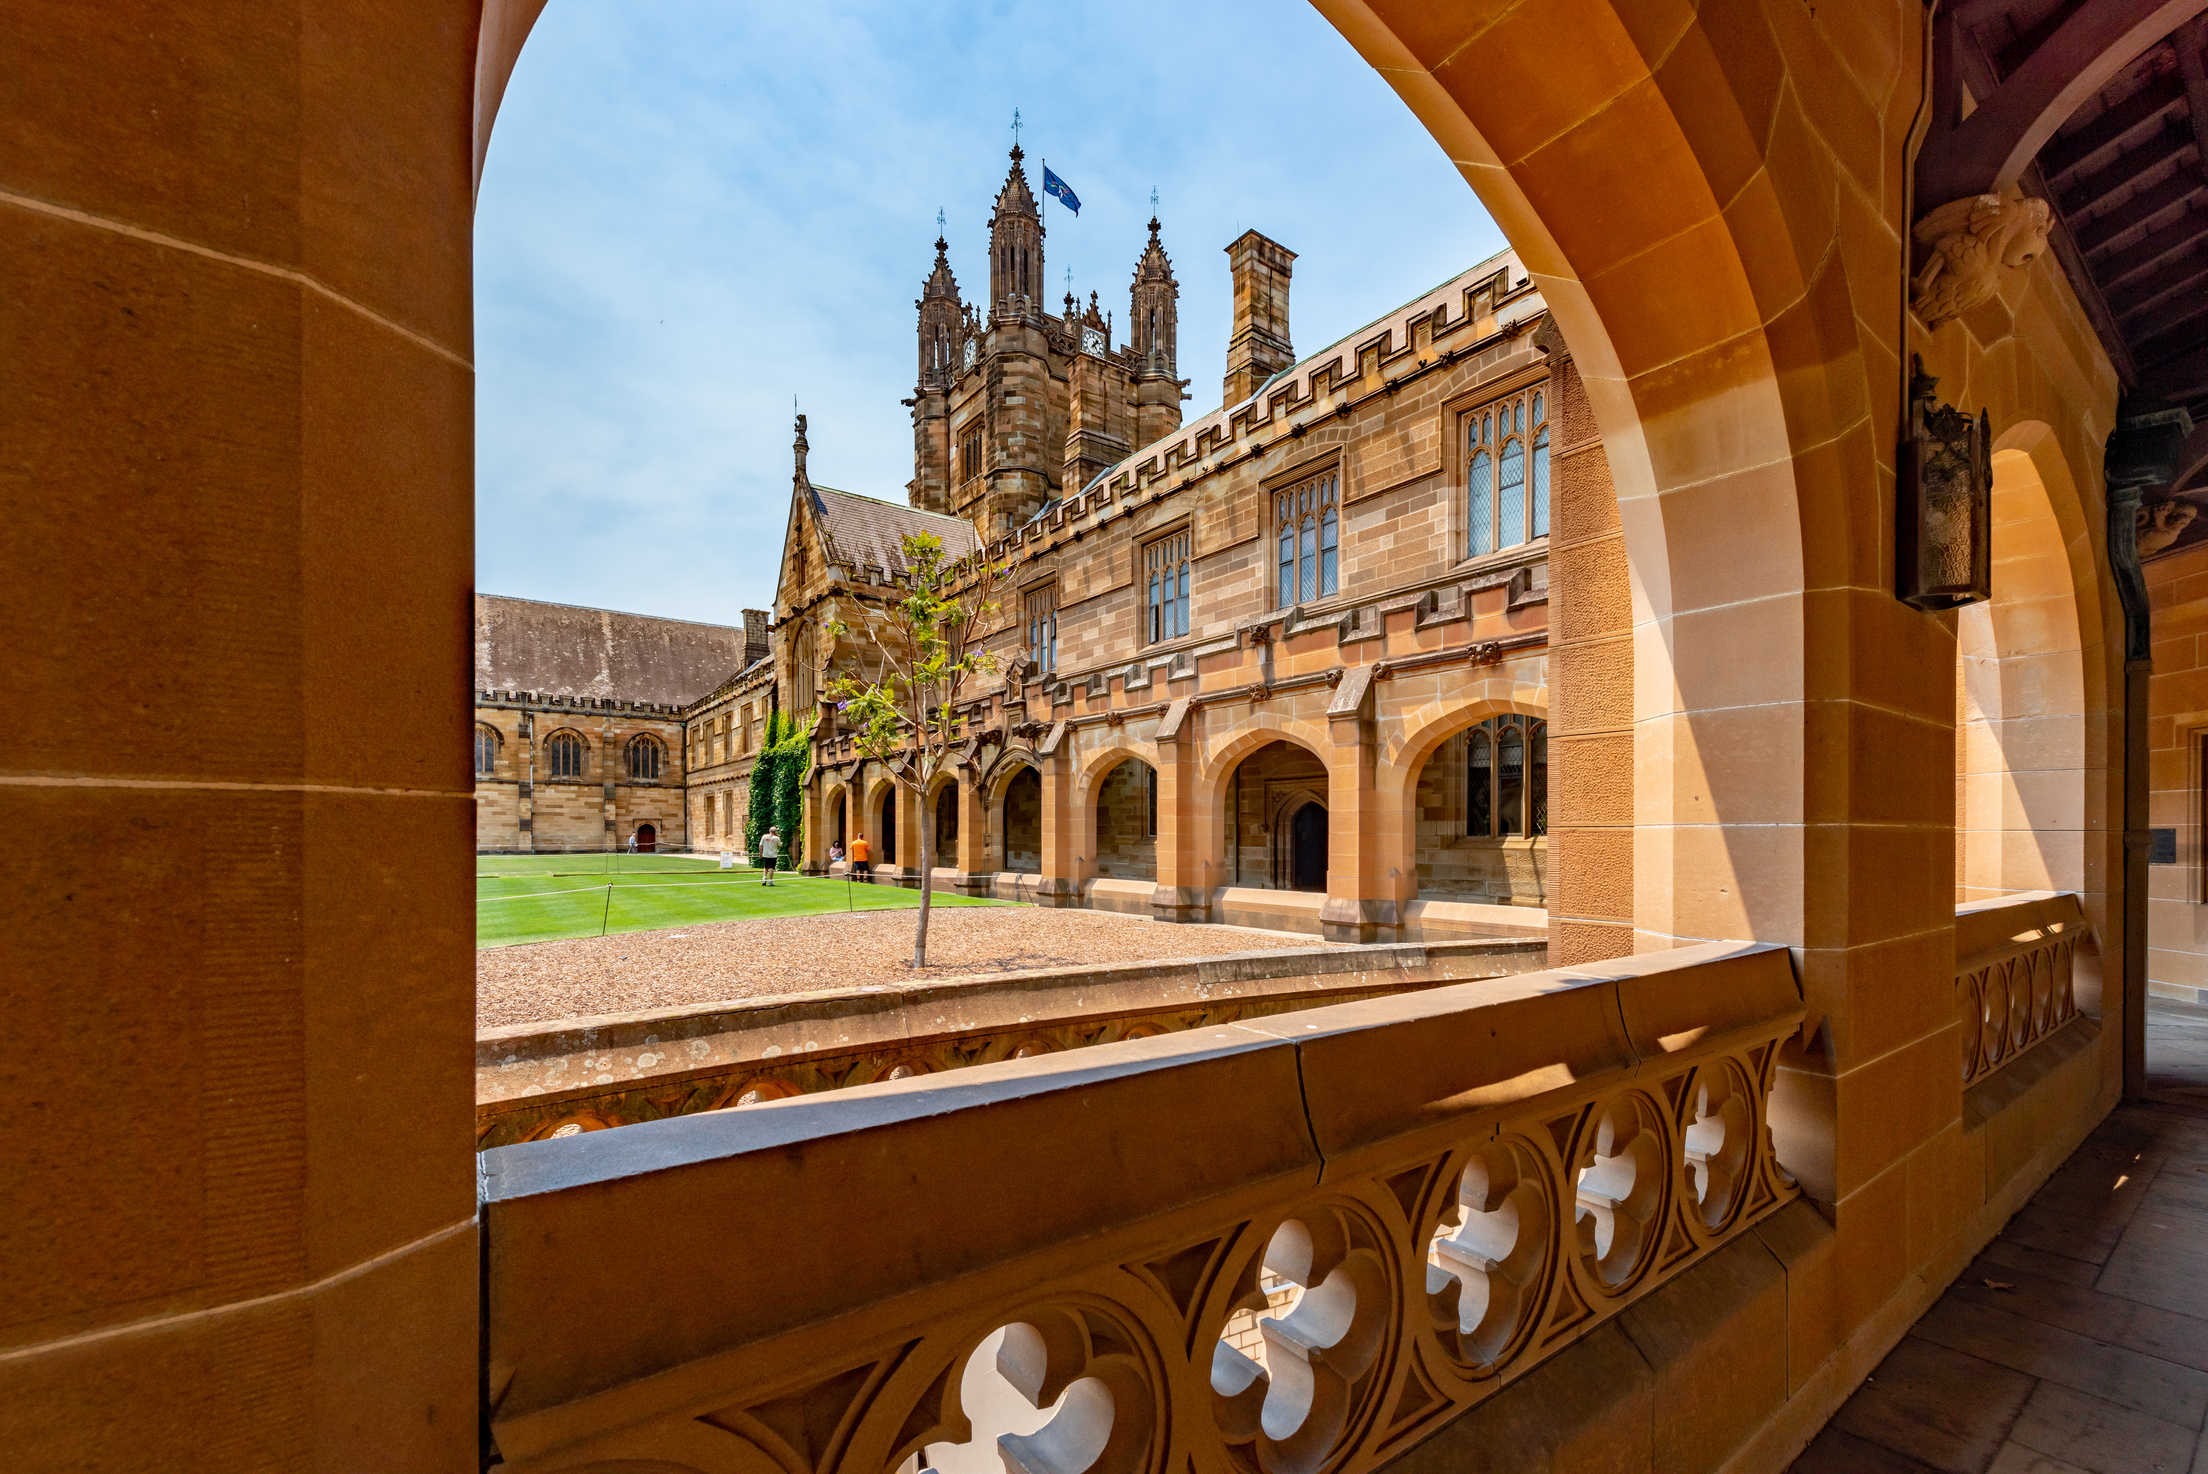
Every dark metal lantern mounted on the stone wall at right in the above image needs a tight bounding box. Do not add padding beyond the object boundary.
[1894,355,1994,609]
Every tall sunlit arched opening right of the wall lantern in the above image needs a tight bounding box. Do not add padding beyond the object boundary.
[1954,450,2089,902]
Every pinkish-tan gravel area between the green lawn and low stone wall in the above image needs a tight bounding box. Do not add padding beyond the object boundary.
[475,907,1325,1028]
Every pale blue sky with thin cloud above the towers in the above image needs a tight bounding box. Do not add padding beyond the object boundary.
[475,0,1504,622]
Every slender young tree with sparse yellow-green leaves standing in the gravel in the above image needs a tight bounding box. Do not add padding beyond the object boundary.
[828,532,1009,966]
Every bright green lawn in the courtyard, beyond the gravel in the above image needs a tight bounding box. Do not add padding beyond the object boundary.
[475,854,1000,947]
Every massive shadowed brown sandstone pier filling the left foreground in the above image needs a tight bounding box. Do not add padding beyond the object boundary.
[0,0,481,1474]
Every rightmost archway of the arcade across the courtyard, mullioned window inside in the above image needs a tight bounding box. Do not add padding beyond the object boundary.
[1409,713,1548,907]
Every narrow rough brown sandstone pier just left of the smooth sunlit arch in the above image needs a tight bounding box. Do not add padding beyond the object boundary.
[1535,320,1634,966]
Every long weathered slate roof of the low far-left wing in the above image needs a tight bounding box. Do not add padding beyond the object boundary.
[475,594,744,706]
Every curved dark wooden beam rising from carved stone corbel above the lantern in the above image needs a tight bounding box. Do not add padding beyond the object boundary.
[1917,0,2208,214]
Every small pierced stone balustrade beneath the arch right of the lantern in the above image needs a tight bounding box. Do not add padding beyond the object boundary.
[1954,891,2093,1088]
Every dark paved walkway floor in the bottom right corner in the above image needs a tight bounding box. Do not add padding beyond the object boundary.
[1793,1000,2208,1474]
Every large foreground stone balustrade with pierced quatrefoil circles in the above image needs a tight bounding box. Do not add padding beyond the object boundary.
[479,944,1804,1474]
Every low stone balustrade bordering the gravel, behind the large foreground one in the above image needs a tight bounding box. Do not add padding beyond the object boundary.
[475,938,1548,1147]
